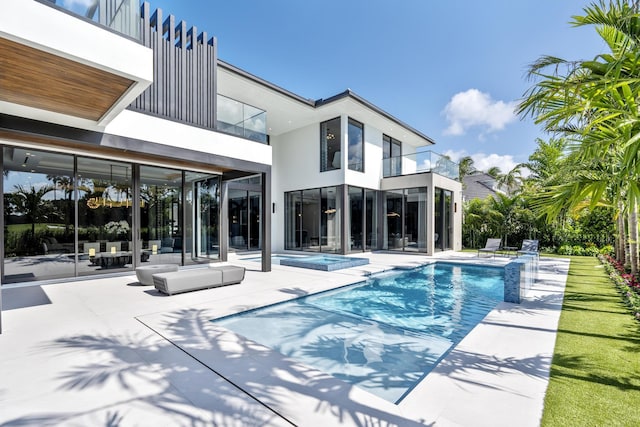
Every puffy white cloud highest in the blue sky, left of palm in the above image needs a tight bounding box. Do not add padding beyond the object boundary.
[443,89,517,137]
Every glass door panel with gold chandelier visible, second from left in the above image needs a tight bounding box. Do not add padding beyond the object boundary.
[77,157,133,276]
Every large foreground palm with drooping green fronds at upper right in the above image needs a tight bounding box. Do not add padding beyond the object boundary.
[518,0,640,272]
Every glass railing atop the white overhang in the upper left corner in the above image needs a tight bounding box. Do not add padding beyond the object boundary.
[43,0,140,40]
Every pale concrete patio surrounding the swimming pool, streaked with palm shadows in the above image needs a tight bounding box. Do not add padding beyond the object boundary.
[0,253,569,426]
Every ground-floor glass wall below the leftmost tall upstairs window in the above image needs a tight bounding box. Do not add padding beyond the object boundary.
[285,187,342,253]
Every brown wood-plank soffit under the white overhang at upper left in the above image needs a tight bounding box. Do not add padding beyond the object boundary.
[0,37,134,122]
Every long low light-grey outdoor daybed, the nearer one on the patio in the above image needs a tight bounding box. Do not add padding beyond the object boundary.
[152,265,245,295]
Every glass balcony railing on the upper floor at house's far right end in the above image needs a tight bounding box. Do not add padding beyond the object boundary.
[382,151,459,180]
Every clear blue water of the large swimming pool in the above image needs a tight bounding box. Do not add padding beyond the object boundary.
[213,263,504,402]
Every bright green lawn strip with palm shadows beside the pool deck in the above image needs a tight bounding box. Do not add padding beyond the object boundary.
[541,257,640,427]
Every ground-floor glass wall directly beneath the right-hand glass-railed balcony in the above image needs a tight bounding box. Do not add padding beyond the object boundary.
[384,188,427,252]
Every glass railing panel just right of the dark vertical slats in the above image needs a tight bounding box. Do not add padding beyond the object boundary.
[216,95,267,144]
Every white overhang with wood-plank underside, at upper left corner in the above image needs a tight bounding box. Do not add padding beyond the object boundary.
[0,0,153,128]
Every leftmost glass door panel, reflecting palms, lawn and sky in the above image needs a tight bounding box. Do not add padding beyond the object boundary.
[2,147,76,283]
